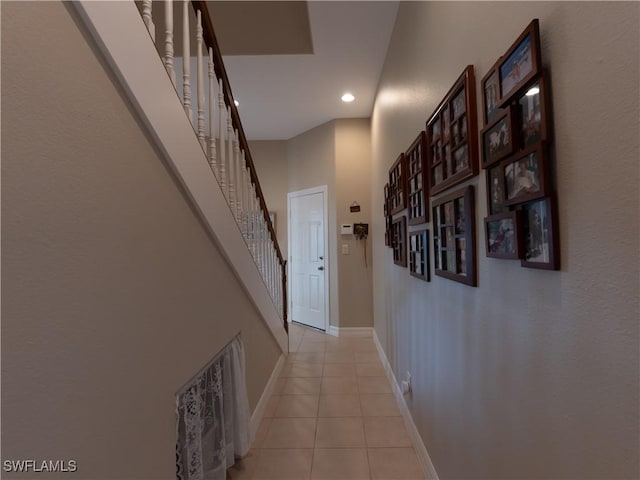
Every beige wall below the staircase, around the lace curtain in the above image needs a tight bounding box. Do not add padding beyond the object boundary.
[2,2,280,479]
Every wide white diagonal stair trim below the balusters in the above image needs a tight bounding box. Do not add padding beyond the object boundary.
[73,1,288,352]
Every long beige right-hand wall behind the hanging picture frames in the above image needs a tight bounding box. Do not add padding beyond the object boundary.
[372,2,640,479]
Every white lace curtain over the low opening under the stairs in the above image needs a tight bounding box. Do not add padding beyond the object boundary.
[176,335,253,480]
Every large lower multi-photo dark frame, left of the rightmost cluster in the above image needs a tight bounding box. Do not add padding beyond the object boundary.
[433,185,478,287]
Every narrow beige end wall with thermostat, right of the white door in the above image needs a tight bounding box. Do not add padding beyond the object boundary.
[335,119,373,328]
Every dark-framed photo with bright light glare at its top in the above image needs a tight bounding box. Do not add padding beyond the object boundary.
[518,71,551,148]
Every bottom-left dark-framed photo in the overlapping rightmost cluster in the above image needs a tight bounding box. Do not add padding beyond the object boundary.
[484,210,522,259]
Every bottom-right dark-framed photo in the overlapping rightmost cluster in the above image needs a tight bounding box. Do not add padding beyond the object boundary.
[520,197,560,270]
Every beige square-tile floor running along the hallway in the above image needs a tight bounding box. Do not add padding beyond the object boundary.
[228,324,425,480]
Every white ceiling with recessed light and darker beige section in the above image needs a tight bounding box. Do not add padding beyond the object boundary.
[208,1,398,140]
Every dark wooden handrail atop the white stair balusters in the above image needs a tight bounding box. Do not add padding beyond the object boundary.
[191,0,286,270]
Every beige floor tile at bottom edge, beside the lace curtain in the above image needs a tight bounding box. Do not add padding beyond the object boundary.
[252,449,313,480]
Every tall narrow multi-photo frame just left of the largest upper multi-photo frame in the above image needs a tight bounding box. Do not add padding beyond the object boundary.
[404,132,429,225]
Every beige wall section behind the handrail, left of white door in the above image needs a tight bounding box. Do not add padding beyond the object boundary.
[249,140,288,258]
